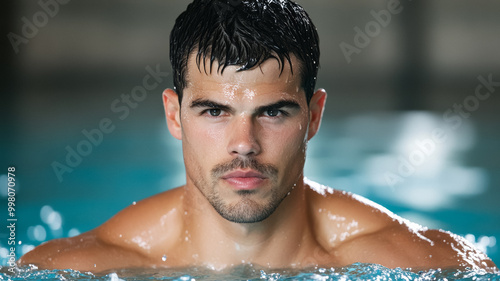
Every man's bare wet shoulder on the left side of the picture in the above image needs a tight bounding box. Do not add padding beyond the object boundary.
[19,186,187,272]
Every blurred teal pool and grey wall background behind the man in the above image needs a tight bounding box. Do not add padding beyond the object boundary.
[0,0,500,265]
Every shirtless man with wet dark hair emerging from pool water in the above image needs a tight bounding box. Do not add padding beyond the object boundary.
[20,0,496,271]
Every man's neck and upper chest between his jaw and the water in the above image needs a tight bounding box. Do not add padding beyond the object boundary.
[180,178,312,268]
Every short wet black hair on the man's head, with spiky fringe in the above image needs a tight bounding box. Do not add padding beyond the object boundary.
[170,0,320,103]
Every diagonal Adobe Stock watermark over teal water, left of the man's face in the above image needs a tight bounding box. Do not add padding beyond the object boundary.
[51,64,169,182]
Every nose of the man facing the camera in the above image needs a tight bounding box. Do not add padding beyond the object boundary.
[227,116,261,157]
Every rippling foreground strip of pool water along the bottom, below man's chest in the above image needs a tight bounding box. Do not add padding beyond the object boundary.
[0,263,500,281]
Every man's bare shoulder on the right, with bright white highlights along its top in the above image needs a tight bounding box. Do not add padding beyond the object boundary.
[307,179,498,271]
